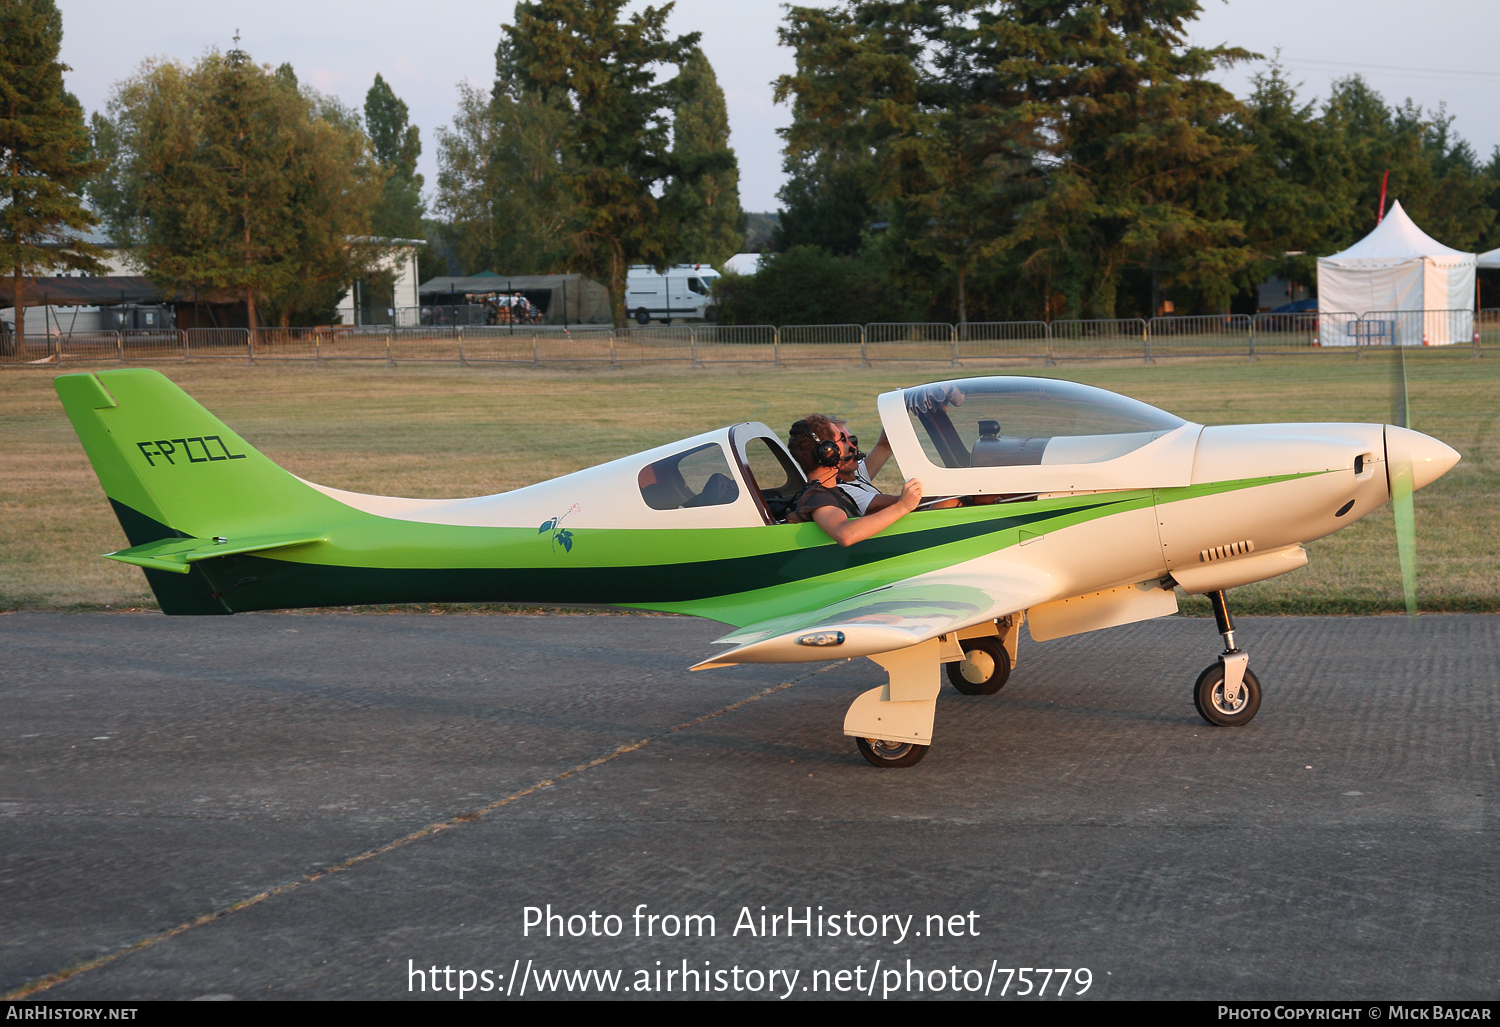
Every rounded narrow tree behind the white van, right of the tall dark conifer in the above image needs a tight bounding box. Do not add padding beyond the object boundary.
[663,46,746,265]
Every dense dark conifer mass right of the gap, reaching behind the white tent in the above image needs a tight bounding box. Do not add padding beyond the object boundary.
[725,0,1500,324]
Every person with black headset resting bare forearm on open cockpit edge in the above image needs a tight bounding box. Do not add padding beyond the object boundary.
[786,414,923,546]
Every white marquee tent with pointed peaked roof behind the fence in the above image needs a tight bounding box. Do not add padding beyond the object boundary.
[1317,202,1488,346]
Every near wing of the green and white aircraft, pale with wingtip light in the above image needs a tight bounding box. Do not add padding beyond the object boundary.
[693,565,1056,670]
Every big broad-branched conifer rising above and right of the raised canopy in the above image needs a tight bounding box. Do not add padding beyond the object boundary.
[969,0,1254,318]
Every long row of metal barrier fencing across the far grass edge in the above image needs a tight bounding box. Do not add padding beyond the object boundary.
[0,309,1500,367]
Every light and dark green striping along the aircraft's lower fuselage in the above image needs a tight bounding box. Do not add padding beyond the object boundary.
[111,475,1326,625]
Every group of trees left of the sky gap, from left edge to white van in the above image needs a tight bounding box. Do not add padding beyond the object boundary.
[0,0,744,330]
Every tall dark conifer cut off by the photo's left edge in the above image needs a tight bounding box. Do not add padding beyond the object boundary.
[0,0,104,347]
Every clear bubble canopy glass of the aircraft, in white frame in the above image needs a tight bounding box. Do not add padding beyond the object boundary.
[902,376,1188,468]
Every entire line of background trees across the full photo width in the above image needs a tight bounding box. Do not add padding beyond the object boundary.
[0,0,1500,332]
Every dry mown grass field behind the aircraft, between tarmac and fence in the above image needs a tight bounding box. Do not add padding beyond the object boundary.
[0,348,1500,613]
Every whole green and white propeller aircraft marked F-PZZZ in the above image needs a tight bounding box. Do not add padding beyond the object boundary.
[56,369,1458,766]
